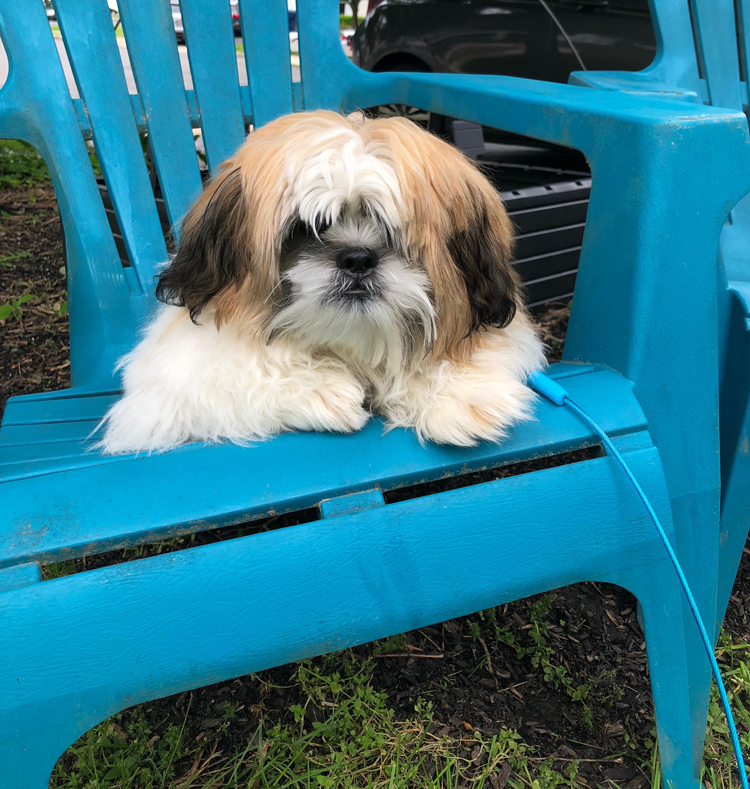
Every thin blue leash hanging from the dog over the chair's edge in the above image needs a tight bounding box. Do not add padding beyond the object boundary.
[528,371,748,789]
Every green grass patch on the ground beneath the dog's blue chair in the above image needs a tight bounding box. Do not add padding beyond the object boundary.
[50,650,592,789]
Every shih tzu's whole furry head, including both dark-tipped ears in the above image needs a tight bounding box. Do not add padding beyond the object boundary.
[157,112,519,365]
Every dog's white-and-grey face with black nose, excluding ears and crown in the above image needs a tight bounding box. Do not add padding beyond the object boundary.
[268,200,435,366]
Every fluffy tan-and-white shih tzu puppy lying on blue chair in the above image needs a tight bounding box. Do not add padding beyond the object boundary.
[101,111,545,453]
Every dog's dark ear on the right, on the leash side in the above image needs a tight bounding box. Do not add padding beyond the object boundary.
[448,189,518,333]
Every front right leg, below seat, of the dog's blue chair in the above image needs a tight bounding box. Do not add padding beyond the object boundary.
[633,563,710,789]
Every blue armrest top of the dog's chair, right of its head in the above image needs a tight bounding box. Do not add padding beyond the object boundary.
[344,66,750,172]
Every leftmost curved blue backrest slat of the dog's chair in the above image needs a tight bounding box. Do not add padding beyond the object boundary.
[0,2,139,386]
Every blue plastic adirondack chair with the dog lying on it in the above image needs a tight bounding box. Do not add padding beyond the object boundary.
[0,0,750,789]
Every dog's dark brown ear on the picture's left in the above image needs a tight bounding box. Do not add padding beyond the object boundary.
[156,168,249,323]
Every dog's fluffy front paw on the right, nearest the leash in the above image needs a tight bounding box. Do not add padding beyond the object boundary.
[414,381,534,447]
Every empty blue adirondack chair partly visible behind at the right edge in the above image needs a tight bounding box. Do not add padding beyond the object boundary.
[570,0,750,768]
